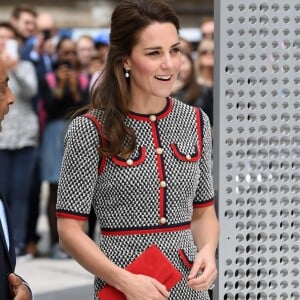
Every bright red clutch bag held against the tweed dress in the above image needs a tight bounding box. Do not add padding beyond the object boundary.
[97,245,182,300]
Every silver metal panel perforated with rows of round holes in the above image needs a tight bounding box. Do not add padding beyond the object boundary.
[214,0,300,300]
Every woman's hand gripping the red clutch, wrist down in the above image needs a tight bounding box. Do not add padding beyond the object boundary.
[122,274,170,300]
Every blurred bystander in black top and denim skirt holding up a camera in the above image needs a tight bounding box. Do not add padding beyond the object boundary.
[41,37,89,259]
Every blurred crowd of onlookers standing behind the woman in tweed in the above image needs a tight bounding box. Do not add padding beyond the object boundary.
[0,5,214,259]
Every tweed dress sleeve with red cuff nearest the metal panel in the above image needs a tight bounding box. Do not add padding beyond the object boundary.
[193,110,214,208]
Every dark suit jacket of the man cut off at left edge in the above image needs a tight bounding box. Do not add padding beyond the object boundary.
[0,194,16,300]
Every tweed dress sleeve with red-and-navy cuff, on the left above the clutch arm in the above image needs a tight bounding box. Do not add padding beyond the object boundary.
[56,116,100,220]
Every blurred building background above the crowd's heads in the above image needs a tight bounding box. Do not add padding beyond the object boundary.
[0,0,213,28]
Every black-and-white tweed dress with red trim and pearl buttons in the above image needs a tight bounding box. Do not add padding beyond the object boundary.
[57,98,214,300]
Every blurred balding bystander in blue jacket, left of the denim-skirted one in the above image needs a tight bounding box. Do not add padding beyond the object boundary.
[20,12,61,257]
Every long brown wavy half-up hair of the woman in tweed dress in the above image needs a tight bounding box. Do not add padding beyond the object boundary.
[91,0,179,157]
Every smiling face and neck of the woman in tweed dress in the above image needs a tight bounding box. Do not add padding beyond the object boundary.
[124,23,181,114]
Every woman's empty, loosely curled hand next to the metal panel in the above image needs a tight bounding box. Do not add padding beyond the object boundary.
[188,247,217,290]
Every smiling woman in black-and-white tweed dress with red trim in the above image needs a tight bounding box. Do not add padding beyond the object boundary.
[57,0,219,300]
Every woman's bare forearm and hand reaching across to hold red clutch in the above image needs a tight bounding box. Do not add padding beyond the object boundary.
[58,218,169,300]
